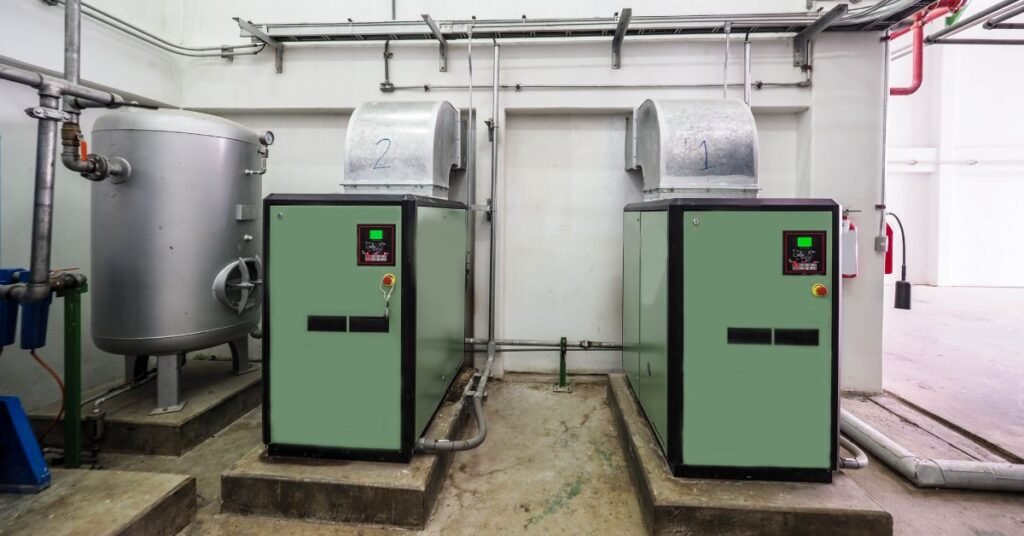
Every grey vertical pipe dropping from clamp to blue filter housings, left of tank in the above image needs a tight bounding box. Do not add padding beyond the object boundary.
[24,93,60,301]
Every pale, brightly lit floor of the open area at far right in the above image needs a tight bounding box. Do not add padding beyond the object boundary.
[883,286,1024,461]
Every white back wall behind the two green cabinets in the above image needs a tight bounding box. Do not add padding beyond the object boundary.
[0,0,882,397]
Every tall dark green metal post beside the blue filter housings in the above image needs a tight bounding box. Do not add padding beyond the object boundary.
[63,287,84,469]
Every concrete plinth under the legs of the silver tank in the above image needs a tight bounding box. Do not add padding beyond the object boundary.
[30,360,263,456]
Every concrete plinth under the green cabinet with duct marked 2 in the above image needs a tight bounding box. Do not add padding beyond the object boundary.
[220,381,468,529]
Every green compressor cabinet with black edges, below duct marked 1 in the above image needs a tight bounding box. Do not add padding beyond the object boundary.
[623,199,840,482]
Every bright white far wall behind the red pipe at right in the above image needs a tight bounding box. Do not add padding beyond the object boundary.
[887,0,1024,287]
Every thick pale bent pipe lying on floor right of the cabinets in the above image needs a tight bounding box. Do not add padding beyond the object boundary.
[840,410,1024,493]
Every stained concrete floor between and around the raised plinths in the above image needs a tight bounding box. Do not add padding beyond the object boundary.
[83,378,1024,536]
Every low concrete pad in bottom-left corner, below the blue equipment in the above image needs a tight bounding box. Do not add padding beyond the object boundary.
[0,469,196,536]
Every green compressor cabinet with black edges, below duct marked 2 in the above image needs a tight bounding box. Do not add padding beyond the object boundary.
[262,195,466,461]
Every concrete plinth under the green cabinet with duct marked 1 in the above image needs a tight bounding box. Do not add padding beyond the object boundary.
[608,374,893,536]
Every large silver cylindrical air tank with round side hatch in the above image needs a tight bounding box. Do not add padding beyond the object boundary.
[89,110,272,360]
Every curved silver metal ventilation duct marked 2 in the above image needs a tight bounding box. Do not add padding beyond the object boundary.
[342,101,463,199]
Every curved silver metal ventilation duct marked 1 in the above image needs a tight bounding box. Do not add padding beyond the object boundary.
[626,99,758,200]
